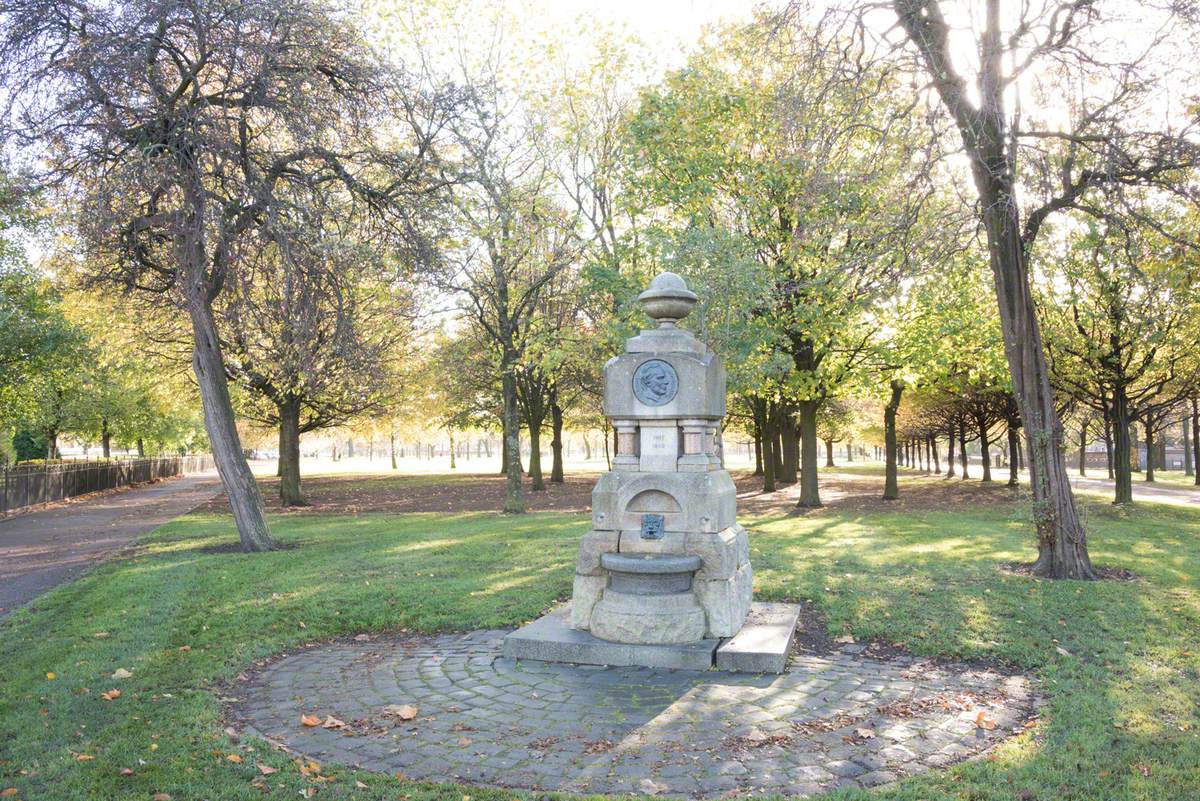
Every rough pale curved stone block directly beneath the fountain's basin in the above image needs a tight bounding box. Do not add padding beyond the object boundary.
[590,588,706,645]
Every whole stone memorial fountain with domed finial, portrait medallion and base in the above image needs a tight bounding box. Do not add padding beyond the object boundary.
[504,272,798,673]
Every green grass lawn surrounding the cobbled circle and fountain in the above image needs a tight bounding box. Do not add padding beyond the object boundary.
[0,470,1200,801]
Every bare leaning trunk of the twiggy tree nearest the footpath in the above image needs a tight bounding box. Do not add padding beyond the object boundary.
[187,290,275,552]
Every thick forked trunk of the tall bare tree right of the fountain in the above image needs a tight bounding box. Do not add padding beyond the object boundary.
[895,0,1096,579]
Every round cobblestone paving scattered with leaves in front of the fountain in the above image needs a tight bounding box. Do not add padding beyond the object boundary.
[229,631,1036,797]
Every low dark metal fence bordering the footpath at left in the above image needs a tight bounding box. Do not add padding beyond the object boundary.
[0,454,214,514]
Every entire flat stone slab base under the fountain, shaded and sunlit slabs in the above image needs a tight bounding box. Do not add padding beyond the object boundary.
[504,603,800,673]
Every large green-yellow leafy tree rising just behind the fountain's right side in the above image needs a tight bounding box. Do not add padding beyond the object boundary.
[629,19,929,506]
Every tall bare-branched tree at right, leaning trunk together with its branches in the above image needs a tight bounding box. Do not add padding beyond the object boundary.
[890,0,1196,579]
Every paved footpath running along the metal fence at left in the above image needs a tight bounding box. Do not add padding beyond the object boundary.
[0,471,221,618]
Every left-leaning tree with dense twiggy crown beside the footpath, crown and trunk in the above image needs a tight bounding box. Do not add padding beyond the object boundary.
[0,0,446,550]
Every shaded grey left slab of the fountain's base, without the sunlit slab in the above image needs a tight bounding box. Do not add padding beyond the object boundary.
[504,603,720,670]
